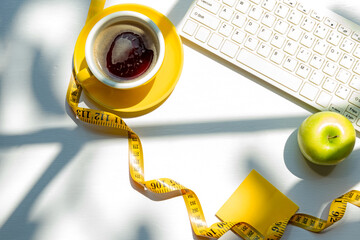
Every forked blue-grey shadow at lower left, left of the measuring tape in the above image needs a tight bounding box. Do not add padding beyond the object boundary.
[0,124,115,240]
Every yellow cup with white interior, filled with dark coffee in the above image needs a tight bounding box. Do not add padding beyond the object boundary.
[76,11,165,89]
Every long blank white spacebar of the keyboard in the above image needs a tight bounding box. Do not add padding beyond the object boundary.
[237,49,302,92]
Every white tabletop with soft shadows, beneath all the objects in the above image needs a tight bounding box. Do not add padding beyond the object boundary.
[0,0,360,240]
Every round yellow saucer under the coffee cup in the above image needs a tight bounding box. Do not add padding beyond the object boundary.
[74,4,183,117]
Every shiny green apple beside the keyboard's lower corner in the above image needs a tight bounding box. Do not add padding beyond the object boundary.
[297,112,356,165]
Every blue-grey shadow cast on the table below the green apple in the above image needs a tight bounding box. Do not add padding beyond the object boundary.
[284,130,360,219]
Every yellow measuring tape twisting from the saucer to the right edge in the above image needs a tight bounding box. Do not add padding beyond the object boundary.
[66,75,360,240]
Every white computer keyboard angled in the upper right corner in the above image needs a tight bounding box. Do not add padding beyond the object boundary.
[179,0,360,132]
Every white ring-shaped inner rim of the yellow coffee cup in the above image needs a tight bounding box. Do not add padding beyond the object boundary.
[85,11,165,89]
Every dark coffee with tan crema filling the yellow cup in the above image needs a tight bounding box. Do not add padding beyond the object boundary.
[93,22,159,82]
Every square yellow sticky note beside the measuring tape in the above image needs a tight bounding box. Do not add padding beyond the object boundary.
[216,170,299,235]
